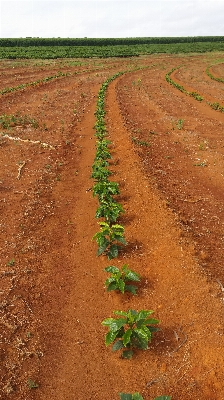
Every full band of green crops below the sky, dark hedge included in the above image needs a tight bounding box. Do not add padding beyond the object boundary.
[0,36,224,59]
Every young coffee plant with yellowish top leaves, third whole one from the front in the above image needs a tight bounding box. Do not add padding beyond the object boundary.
[93,222,127,260]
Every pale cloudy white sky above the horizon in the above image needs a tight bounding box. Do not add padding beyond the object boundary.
[0,0,224,38]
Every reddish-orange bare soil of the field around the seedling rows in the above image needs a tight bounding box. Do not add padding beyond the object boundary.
[0,53,224,400]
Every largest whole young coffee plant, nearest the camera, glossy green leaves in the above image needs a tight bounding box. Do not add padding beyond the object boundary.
[102,310,159,359]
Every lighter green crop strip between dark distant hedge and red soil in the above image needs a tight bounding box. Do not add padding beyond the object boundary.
[0,40,224,60]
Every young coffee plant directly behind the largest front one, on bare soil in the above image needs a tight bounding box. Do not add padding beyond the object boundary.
[104,264,140,294]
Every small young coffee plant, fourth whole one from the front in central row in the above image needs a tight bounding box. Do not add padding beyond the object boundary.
[96,199,124,224]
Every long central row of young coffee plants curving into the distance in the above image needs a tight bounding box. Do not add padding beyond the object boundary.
[91,72,171,400]
